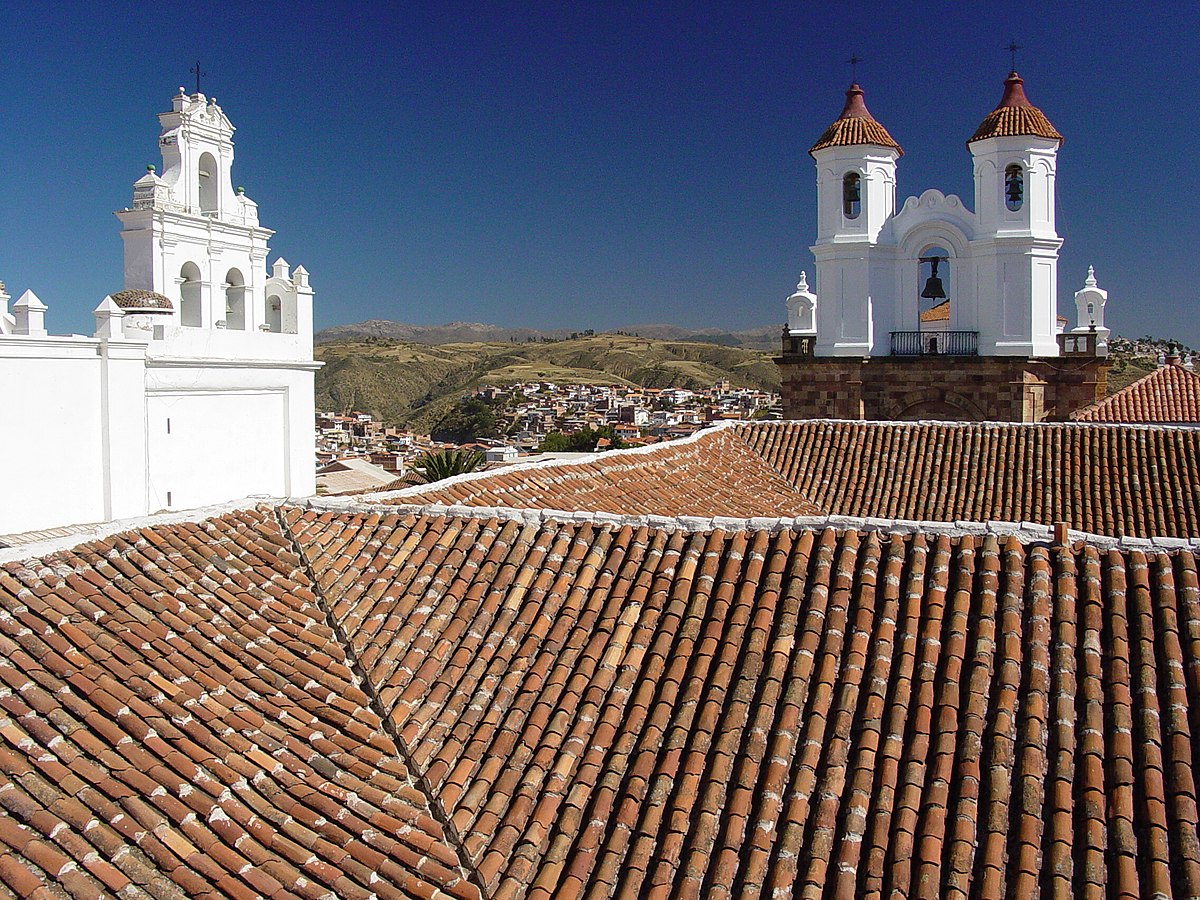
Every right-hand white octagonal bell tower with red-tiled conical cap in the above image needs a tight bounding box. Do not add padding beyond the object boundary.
[967,72,1062,356]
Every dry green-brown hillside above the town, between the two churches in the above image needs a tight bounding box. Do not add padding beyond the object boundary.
[316,335,779,431]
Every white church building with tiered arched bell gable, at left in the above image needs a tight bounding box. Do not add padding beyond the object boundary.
[0,89,320,534]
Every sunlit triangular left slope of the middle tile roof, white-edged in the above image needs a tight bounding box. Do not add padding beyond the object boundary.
[394,430,820,517]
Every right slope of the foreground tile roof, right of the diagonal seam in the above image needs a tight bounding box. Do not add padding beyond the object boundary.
[280,514,1200,898]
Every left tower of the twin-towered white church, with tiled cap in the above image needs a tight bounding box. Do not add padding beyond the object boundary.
[809,83,904,356]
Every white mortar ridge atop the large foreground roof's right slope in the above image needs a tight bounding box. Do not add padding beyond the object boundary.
[290,497,1200,552]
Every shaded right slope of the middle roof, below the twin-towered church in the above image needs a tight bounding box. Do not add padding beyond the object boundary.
[739,420,1200,538]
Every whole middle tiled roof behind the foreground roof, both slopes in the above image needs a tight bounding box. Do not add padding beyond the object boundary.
[380,420,1200,538]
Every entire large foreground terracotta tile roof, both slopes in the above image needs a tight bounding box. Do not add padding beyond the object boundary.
[0,504,1200,898]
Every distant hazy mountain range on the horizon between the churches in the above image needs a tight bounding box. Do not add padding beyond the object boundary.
[313,319,782,352]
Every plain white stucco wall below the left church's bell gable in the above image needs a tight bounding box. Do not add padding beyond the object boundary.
[0,335,317,534]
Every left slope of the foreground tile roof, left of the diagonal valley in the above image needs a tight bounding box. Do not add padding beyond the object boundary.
[0,510,478,898]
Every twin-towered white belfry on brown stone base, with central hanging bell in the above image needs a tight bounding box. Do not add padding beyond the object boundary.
[776,72,1108,421]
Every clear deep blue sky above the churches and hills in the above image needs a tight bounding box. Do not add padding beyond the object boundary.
[0,1,1200,346]
